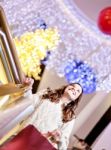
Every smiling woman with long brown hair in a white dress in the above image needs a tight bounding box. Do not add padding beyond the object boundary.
[25,80,83,150]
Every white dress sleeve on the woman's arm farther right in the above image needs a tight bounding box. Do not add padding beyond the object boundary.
[58,119,75,150]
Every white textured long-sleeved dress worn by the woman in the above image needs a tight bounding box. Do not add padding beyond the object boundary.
[23,90,75,150]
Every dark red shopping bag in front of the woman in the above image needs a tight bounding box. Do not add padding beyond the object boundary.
[0,125,56,150]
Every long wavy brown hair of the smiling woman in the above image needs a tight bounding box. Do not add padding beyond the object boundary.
[42,83,83,122]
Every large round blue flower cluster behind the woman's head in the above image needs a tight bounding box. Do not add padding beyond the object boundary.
[64,60,97,94]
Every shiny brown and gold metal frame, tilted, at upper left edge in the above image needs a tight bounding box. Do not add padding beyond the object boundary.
[0,6,24,84]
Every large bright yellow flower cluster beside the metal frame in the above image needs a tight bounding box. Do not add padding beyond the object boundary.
[14,28,60,80]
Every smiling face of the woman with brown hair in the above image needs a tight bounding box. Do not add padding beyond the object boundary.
[64,84,82,100]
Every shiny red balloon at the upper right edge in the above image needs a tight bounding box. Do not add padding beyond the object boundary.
[98,6,111,35]
